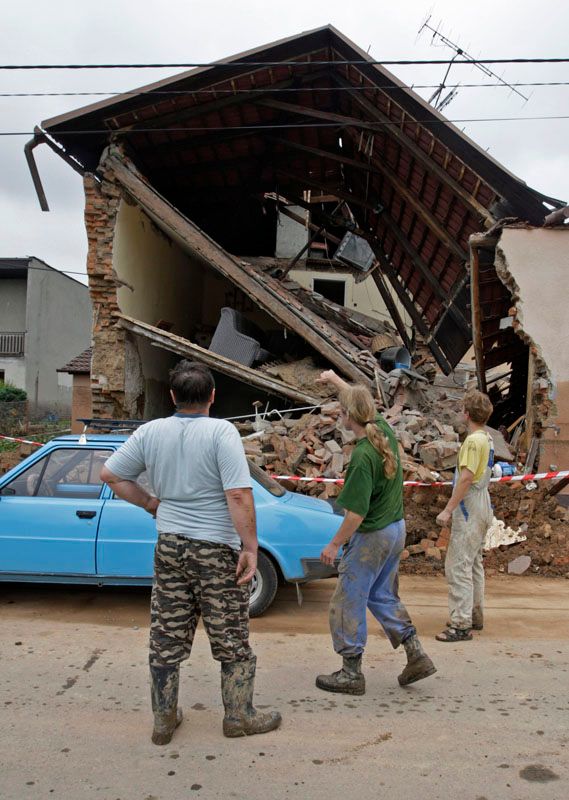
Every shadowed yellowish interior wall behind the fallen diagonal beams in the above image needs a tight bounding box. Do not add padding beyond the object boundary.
[113,202,327,419]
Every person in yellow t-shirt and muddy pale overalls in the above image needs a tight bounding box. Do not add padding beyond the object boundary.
[436,390,494,642]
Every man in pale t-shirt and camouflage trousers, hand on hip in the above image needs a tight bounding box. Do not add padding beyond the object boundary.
[101,361,281,745]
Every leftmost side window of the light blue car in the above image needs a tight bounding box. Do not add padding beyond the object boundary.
[2,448,110,499]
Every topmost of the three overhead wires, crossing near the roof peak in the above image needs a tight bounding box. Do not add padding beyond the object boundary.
[0,58,569,70]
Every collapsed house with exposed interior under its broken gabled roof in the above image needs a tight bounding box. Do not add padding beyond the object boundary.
[26,26,566,476]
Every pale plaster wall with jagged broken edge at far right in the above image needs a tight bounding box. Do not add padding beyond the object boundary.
[496,226,569,469]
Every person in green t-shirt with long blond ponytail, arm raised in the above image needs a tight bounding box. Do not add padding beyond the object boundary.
[316,370,436,694]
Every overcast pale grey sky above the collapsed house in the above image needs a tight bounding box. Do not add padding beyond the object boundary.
[0,0,569,282]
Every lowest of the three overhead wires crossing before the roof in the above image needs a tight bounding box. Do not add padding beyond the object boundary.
[0,111,569,138]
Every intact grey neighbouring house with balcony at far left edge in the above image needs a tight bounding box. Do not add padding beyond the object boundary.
[0,256,91,416]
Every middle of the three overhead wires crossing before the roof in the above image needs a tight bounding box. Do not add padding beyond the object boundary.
[0,81,569,97]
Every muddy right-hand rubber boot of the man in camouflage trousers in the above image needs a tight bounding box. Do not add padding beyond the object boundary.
[221,656,282,738]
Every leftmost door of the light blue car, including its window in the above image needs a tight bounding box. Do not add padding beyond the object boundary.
[0,445,112,576]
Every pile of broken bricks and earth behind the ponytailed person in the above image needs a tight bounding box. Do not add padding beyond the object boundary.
[237,370,569,575]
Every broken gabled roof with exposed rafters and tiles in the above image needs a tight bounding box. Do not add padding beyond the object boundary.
[36,26,558,372]
